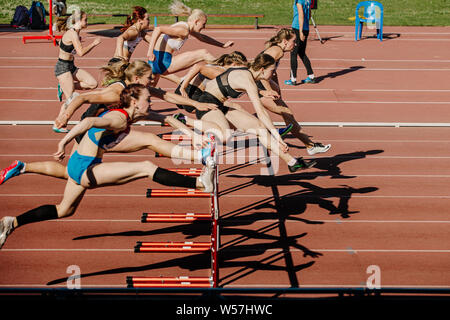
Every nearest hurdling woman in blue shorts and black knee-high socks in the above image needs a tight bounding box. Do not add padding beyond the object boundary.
[0,84,215,248]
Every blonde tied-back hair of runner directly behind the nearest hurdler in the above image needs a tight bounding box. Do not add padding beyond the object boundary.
[101,59,152,86]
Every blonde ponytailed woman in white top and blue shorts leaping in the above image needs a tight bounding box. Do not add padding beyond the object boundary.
[147,0,233,84]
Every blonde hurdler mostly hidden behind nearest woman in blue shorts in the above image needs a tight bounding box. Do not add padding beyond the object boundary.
[0,60,216,185]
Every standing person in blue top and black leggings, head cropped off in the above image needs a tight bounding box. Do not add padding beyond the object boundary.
[284,0,316,86]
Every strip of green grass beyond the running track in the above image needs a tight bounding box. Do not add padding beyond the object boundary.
[0,0,450,26]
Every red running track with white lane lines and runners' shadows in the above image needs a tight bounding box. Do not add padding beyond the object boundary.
[0,26,450,296]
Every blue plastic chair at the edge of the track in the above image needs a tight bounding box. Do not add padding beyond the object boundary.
[355,1,383,41]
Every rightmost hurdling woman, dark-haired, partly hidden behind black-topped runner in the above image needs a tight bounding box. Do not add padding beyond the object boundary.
[256,28,331,155]
